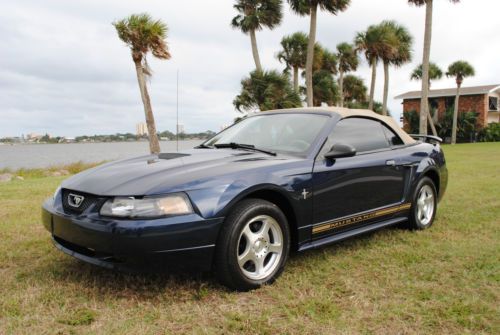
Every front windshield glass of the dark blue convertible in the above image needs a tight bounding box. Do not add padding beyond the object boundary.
[203,113,328,154]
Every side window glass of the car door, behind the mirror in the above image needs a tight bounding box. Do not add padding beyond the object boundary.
[327,117,390,152]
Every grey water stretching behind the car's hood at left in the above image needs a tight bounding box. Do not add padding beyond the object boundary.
[0,141,202,170]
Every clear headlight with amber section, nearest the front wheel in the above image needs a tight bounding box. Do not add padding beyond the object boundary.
[100,193,193,218]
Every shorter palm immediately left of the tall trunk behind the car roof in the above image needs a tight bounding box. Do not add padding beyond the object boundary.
[276,32,308,92]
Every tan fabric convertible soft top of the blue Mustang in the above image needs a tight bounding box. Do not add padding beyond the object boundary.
[266,107,416,144]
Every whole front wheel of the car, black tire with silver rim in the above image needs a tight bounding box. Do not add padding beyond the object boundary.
[215,199,290,291]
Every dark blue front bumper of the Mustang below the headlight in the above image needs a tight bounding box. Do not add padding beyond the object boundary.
[42,199,224,270]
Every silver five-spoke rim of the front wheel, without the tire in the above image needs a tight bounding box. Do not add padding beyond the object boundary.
[237,215,283,280]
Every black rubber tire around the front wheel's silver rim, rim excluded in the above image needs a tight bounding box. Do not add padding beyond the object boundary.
[219,199,290,289]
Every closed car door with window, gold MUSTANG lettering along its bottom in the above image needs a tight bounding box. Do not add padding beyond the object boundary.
[312,117,405,239]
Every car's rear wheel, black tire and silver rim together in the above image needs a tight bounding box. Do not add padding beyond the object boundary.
[408,177,437,230]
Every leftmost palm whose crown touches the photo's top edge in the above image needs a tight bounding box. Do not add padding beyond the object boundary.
[231,0,283,71]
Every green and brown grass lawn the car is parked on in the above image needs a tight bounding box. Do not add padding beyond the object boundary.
[0,143,500,334]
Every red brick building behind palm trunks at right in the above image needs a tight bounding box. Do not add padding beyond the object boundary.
[395,85,500,127]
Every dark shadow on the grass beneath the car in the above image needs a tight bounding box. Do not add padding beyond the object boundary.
[25,226,406,301]
